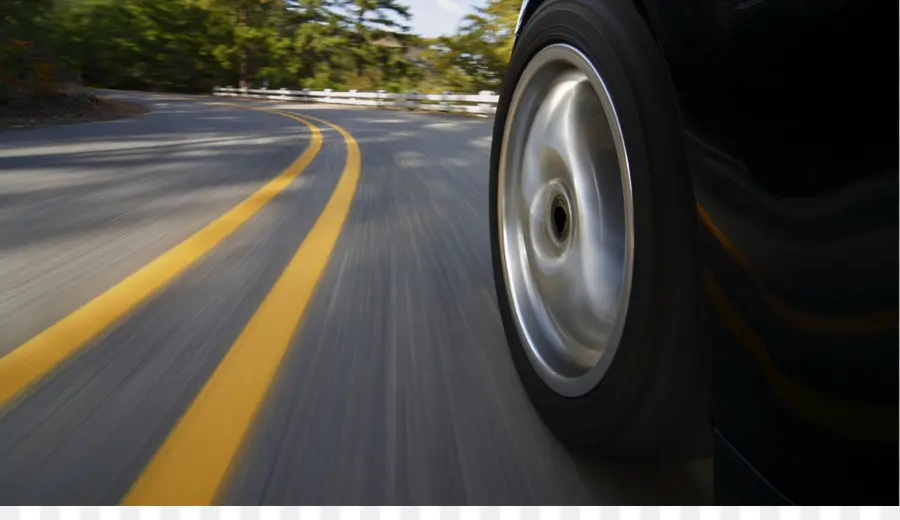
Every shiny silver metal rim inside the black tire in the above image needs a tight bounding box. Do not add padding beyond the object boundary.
[497,44,634,397]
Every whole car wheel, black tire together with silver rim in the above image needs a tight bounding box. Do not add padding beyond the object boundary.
[490,0,710,457]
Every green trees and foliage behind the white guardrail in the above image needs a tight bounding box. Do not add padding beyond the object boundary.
[0,0,521,96]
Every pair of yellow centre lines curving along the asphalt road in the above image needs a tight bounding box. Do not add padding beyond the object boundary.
[0,105,361,505]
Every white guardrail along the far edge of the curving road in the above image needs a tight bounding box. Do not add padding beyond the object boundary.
[213,87,499,115]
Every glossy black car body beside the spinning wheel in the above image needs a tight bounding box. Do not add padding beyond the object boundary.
[517,0,900,504]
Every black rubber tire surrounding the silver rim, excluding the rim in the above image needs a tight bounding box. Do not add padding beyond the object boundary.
[490,0,711,458]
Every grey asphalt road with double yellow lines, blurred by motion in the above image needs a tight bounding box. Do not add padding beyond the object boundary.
[0,93,711,505]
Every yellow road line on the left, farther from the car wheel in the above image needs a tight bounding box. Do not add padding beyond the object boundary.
[0,107,322,407]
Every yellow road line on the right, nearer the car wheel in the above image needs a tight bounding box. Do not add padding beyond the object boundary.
[123,112,360,505]
